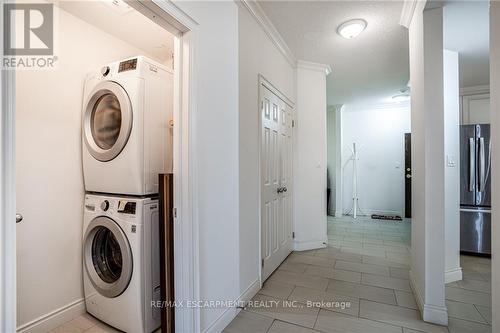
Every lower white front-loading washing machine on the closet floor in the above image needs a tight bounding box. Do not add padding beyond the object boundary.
[83,194,161,333]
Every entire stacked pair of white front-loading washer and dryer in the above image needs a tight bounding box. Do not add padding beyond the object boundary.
[82,56,173,333]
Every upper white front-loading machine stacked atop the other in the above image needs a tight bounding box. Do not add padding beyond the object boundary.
[82,56,173,195]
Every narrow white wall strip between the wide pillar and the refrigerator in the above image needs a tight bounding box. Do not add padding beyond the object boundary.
[443,48,462,283]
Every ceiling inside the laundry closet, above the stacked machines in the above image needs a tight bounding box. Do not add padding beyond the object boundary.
[57,0,174,63]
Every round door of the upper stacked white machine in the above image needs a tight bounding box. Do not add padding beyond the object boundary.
[83,81,132,162]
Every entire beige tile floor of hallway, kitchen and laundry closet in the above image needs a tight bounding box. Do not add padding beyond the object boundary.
[51,217,491,333]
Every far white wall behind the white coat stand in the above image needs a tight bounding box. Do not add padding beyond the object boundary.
[342,103,411,215]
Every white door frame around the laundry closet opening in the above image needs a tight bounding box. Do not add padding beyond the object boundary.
[0,0,200,332]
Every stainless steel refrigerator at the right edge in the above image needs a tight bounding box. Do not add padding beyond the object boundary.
[460,125,491,254]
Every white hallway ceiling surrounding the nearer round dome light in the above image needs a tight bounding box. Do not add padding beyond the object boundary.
[259,0,409,105]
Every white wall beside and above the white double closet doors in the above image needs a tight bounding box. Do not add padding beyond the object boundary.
[238,5,295,295]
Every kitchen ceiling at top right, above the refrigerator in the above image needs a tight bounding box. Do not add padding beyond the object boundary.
[443,1,490,87]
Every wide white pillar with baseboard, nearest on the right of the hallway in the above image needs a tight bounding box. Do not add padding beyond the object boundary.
[409,3,448,325]
